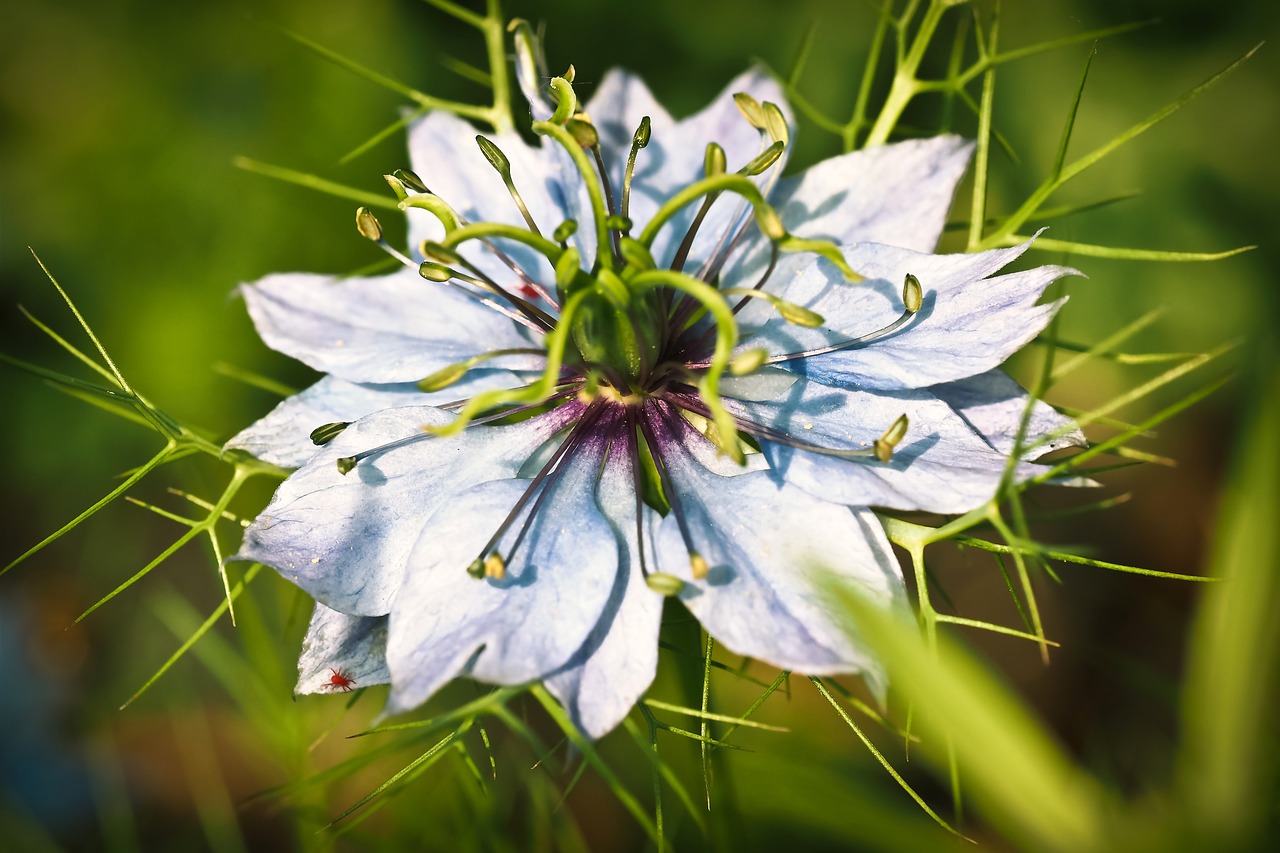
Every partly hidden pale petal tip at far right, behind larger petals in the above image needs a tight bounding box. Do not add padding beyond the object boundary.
[929,370,1087,457]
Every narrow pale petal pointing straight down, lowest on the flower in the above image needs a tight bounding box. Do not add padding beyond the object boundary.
[547,435,663,738]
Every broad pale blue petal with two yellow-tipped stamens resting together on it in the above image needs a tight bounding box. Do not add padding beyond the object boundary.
[387,427,618,713]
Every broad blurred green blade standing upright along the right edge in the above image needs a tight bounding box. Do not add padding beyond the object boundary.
[1179,362,1280,835]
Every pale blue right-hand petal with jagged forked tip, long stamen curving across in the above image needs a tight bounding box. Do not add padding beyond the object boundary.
[741,235,1078,389]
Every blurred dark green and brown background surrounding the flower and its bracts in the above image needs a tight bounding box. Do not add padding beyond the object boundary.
[0,0,1280,849]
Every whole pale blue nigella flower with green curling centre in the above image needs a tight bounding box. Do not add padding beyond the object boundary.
[230,61,1076,736]
